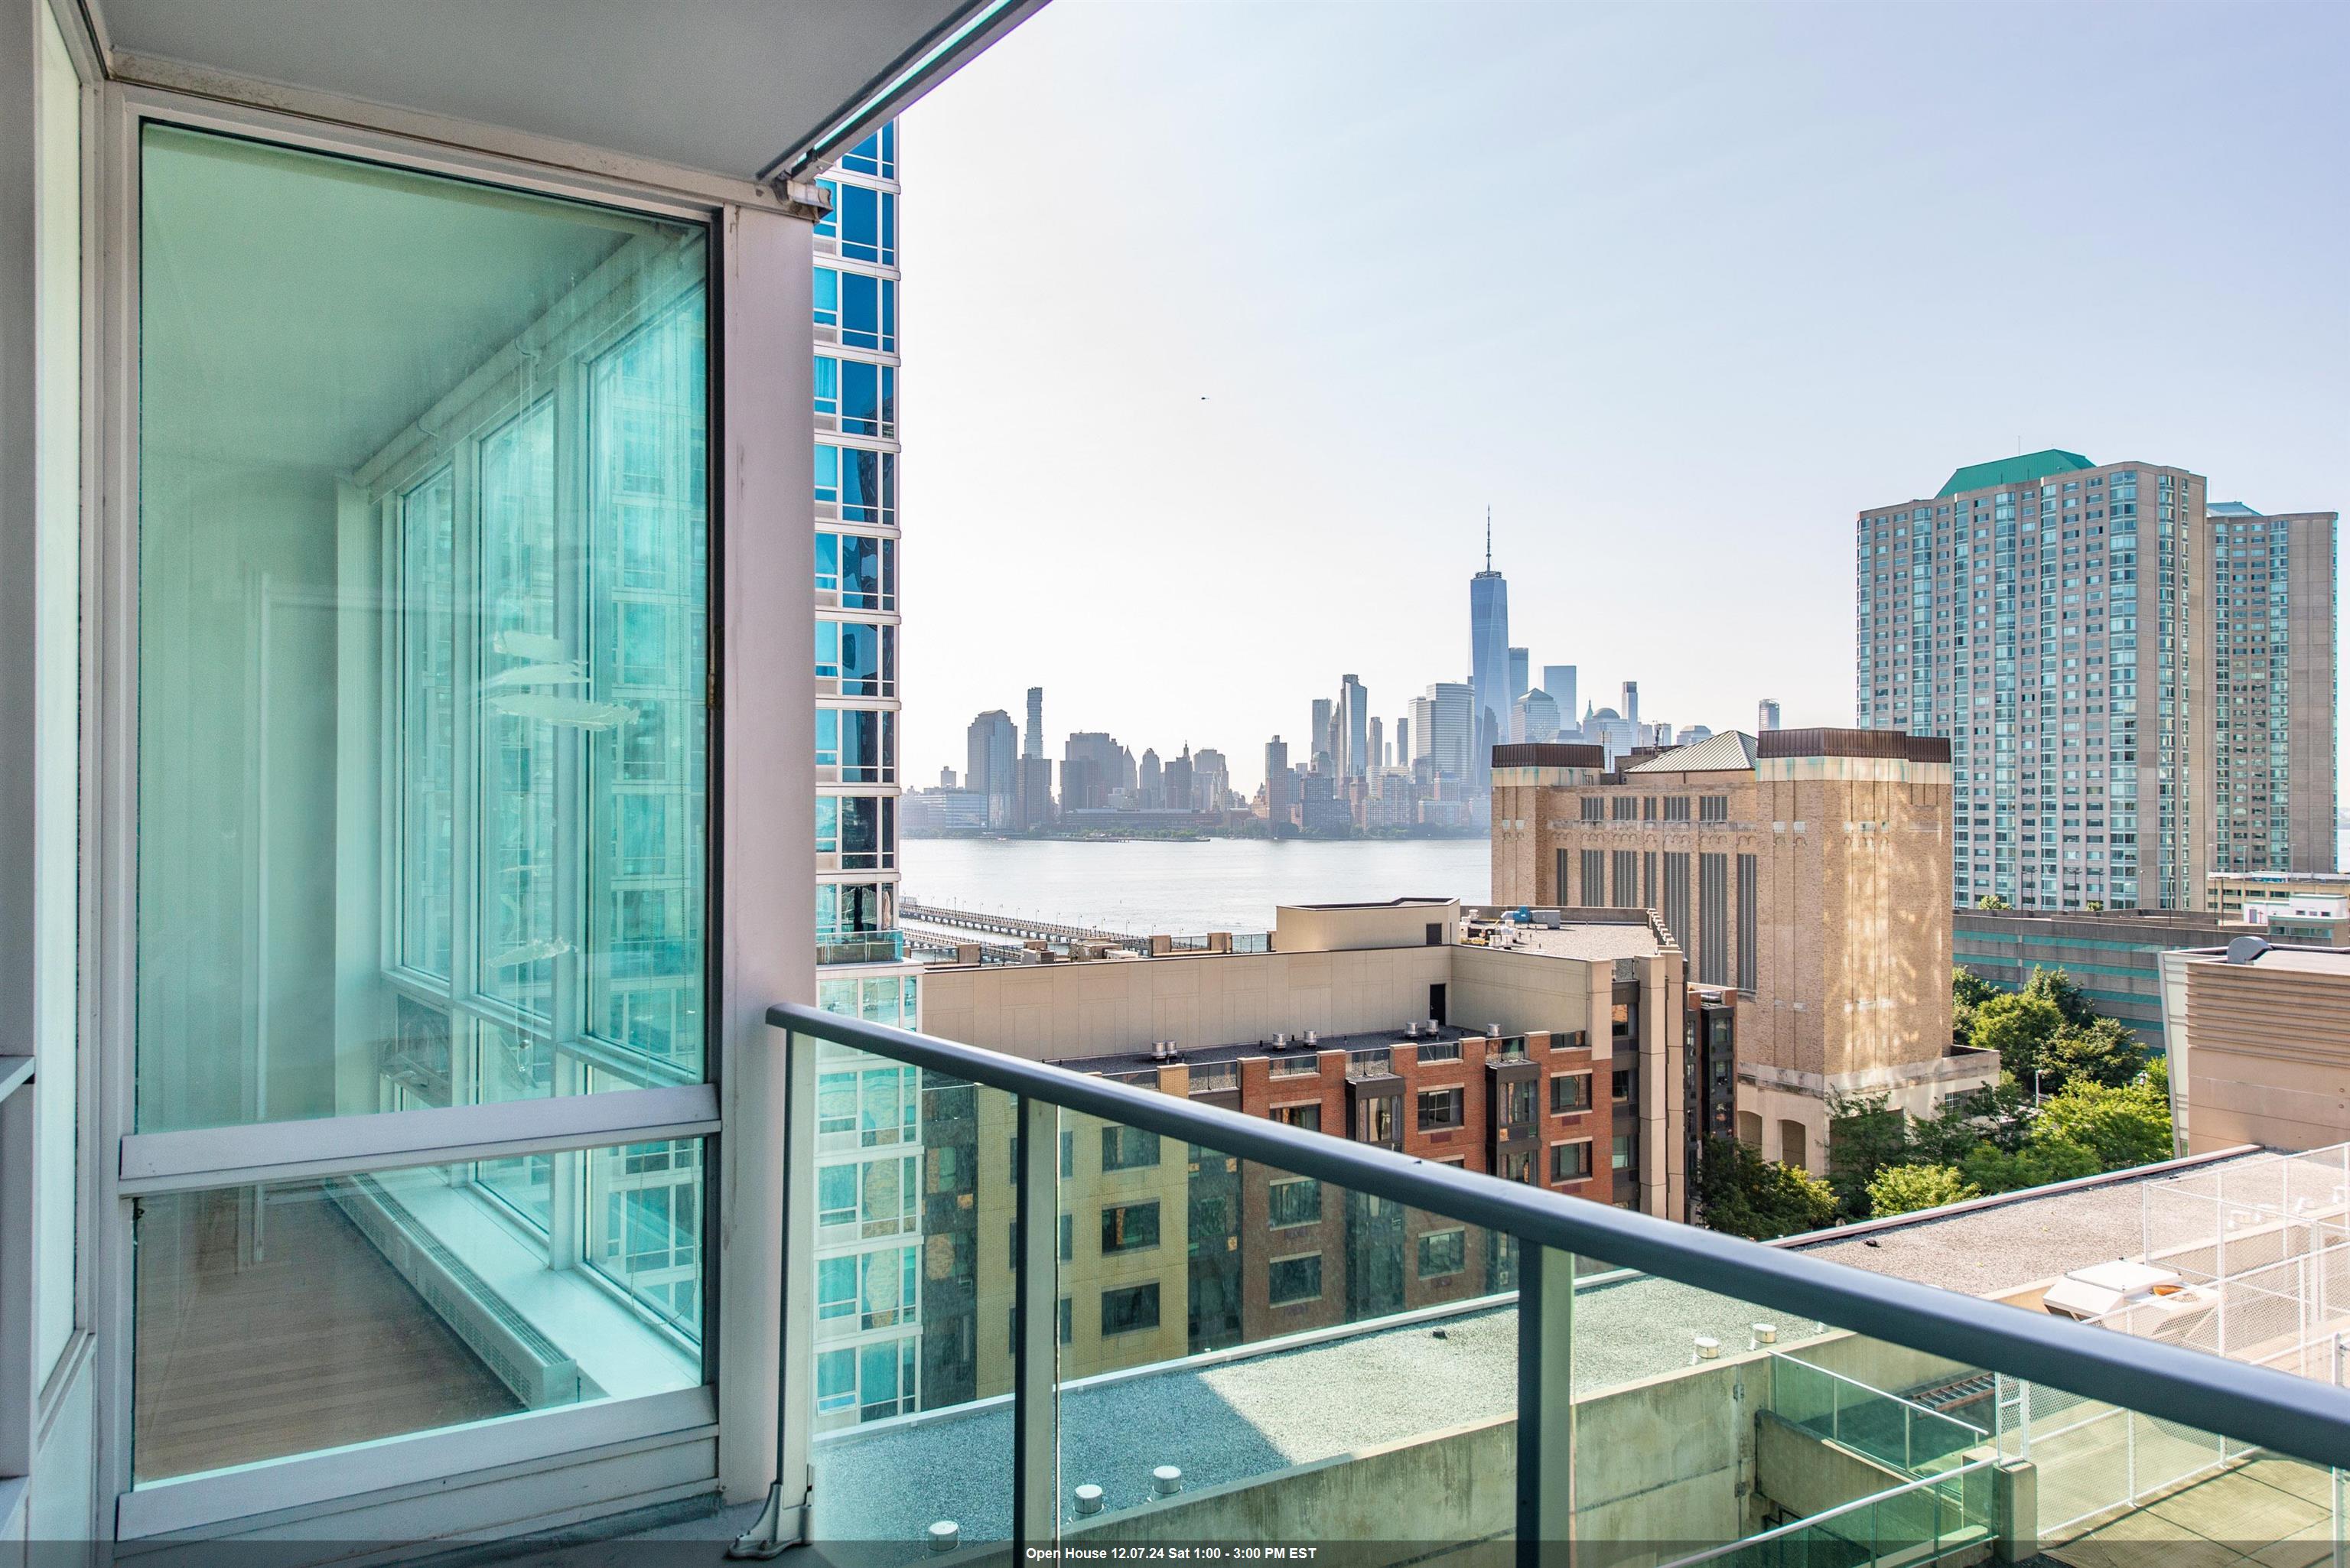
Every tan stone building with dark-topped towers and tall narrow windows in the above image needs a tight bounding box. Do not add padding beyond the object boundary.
[1492,729,1997,1171]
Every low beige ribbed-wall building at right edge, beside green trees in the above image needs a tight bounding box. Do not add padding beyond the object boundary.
[2162,935,2350,1154]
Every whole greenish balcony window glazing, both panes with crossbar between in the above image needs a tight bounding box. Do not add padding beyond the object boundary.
[122,122,717,1488]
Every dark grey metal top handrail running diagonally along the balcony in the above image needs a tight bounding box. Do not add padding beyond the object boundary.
[766,1004,2350,1469]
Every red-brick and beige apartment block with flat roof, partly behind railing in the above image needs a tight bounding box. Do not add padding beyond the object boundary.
[923,898,1701,1389]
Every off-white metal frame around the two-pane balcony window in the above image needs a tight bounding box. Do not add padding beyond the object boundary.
[83,85,813,1540]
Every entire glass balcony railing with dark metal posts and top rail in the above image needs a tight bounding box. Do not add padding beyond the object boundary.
[740,1006,2350,1568]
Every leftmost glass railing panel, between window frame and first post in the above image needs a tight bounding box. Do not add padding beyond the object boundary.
[794,1052,1017,1563]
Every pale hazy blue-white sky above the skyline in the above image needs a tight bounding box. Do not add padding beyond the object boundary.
[903,0,2350,788]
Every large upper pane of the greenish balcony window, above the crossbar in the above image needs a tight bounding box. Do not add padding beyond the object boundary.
[136,127,708,1128]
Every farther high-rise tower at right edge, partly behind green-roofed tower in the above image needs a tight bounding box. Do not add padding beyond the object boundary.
[2207,501,2341,872]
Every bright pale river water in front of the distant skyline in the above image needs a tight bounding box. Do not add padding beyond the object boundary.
[898,839,1492,935]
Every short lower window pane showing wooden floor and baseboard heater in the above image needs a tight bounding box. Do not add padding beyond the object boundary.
[132,1143,703,1485]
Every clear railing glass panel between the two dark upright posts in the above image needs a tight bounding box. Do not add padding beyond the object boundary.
[1057,1112,1518,1561]
